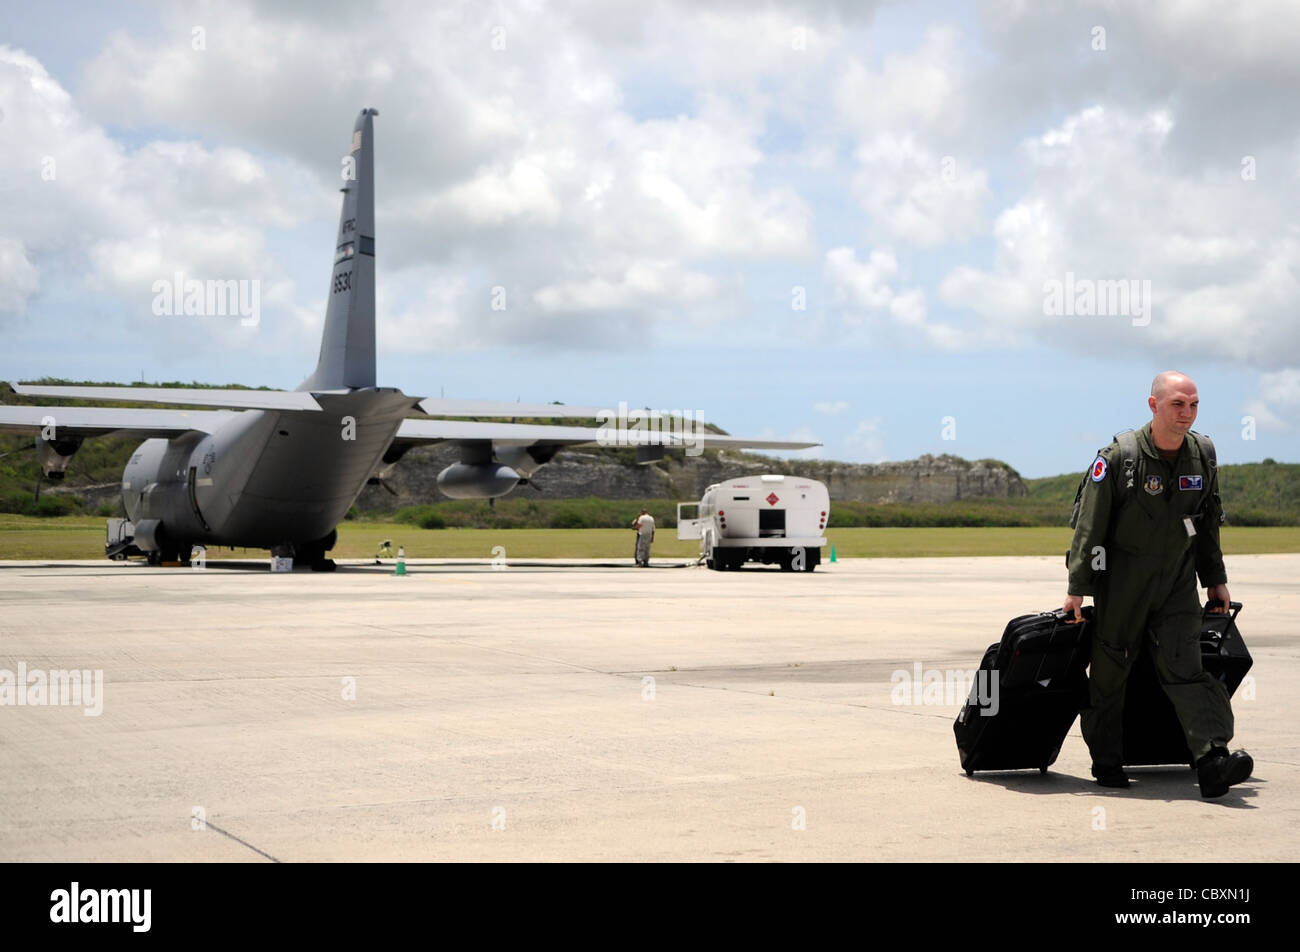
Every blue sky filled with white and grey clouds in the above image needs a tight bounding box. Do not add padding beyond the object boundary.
[0,0,1300,476]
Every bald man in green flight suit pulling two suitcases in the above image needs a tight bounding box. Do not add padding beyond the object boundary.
[1065,371,1255,797]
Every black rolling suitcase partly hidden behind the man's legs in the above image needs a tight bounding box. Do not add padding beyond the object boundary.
[1125,602,1252,767]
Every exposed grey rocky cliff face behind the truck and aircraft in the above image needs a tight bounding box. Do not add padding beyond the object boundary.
[358,447,1028,510]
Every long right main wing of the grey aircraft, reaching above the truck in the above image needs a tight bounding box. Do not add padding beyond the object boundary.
[393,419,820,450]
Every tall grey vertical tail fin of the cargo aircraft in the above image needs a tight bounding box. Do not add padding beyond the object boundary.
[298,109,380,390]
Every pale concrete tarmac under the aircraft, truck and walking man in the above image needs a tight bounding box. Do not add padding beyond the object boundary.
[0,555,1300,862]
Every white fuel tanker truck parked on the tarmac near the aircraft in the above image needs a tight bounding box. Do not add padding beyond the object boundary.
[677,475,831,572]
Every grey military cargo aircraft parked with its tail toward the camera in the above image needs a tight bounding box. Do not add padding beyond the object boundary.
[0,109,816,571]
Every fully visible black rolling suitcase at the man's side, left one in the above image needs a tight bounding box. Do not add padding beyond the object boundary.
[953,606,1092,776]
